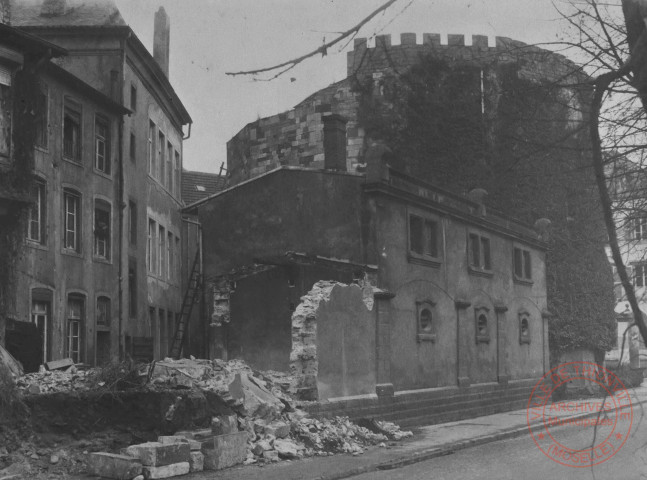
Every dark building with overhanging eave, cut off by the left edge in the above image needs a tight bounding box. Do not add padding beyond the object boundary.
[0,17,65,356]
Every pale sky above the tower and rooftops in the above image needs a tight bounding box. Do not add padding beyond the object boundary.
[116,0,596,172]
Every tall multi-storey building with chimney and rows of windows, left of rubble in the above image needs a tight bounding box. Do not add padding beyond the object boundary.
[12,0,191,364]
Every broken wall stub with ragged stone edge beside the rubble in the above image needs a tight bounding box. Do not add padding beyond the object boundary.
[290,282,376,400]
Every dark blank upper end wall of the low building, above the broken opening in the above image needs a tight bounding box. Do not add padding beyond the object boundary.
[197,169,375,277]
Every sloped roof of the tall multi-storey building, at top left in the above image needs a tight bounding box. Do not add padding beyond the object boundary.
[11,0,126,27]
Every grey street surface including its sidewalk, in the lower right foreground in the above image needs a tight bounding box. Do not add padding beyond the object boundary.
[183,387,647,480]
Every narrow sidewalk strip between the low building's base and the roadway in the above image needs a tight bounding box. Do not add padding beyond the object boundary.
[192,386,647,480]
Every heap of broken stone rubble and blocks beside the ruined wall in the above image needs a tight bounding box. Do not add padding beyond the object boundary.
[11,358,412,478]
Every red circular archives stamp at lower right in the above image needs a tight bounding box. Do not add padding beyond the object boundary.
[526,362,633,468]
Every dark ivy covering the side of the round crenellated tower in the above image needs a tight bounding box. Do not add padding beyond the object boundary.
[355,51,615,359]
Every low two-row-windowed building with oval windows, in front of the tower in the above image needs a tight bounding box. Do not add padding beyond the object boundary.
[186,139,550,417]
